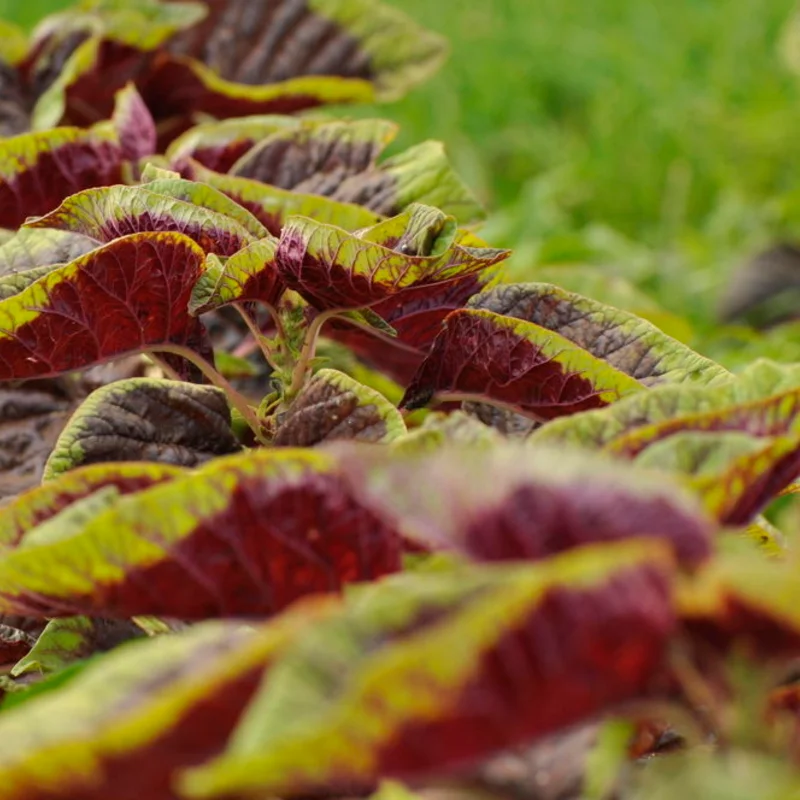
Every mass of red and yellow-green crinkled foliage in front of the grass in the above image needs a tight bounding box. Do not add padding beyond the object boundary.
[0,0,800,800]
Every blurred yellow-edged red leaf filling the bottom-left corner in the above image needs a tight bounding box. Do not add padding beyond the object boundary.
[0,605,332,800]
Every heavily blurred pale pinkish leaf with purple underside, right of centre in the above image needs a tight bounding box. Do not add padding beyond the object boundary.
[338,442,713,565]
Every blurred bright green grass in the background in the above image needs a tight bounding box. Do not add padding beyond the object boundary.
[0,0,800,355]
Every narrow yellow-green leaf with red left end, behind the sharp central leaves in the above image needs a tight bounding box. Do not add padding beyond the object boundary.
[181,161,381,236]
